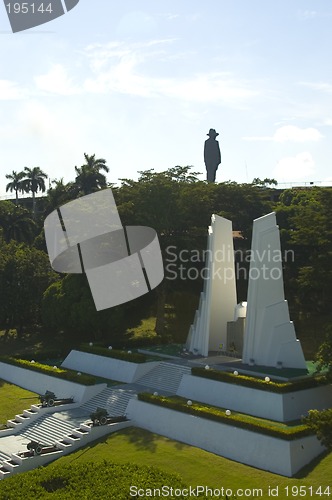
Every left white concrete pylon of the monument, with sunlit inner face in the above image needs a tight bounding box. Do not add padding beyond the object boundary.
[186,215,236,356]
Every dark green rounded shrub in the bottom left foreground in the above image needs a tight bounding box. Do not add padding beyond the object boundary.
[0,460,197,500]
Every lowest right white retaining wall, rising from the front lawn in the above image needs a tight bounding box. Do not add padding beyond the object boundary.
[127,399,324,477]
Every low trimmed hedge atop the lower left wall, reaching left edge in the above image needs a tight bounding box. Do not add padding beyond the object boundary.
[0,357,96,385]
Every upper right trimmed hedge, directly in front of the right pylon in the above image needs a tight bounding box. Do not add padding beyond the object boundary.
[191,367,329,394]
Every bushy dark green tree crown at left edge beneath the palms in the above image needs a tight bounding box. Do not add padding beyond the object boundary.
[0,201,36,243]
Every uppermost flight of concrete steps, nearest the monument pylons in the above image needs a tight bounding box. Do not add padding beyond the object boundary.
[135,361,191,394]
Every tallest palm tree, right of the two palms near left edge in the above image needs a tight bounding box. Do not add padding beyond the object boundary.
[75,153,109,194]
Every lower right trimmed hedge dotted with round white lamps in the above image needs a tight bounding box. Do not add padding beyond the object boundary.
[138,392,313,441]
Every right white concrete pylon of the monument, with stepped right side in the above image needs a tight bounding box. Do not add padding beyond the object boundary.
[242,213,306,369]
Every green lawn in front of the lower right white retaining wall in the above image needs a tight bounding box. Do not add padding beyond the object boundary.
[50,428,332,498]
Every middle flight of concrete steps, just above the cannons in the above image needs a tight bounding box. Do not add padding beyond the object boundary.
[80,387,136,417]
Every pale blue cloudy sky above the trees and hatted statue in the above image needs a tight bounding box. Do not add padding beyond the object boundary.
[0,0,332,196]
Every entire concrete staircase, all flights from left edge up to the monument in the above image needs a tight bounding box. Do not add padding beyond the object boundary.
[0,361,191,479]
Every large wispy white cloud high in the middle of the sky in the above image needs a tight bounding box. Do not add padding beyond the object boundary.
[84,40,259,107]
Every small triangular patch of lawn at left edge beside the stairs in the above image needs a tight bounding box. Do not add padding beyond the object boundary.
[0,380,39,429]
